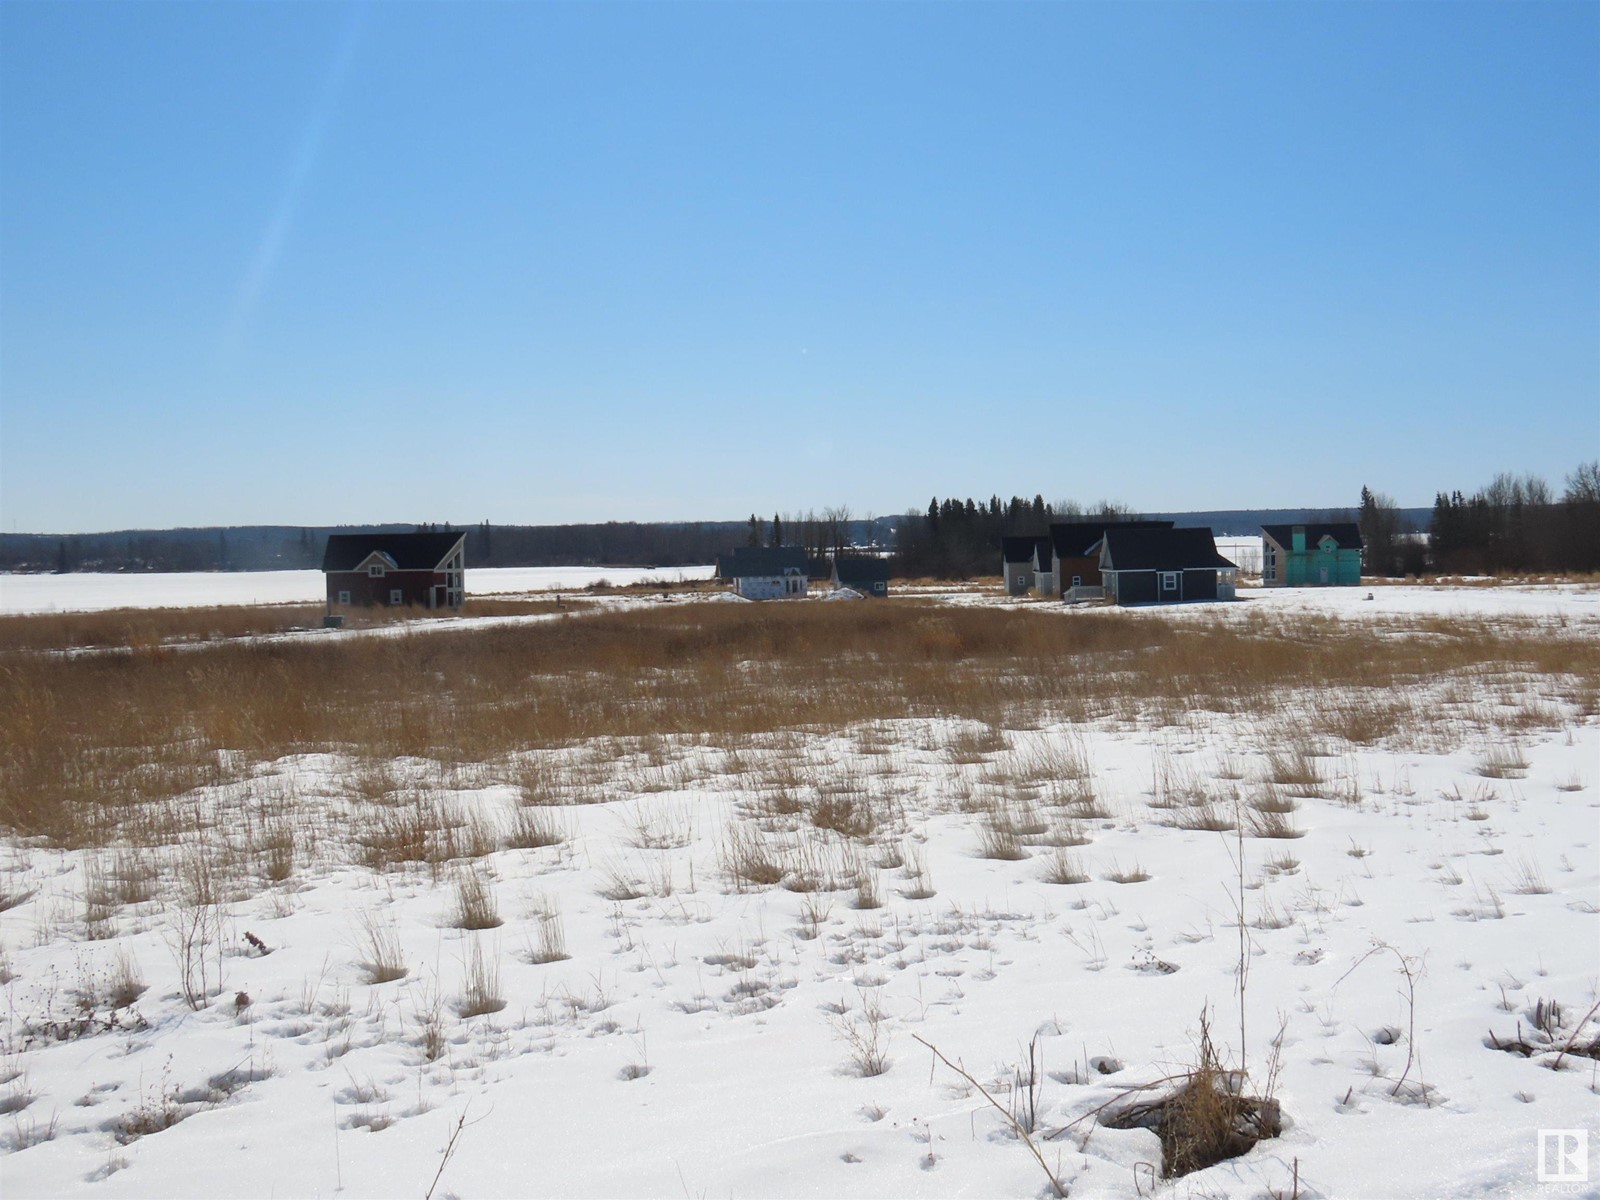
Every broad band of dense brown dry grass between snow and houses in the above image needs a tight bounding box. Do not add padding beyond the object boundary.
[0,600,1600,851]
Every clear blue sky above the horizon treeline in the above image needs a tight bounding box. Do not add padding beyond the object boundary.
[0,0,1600,531]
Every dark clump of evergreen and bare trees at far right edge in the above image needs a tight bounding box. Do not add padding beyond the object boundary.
[1429,461,1600,574]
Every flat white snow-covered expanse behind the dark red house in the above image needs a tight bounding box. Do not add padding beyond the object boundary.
[0,566,717,613]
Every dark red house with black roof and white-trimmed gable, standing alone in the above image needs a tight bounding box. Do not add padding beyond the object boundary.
[322,533,467,610]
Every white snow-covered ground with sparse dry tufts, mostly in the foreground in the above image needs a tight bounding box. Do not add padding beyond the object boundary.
[0,585,1600,1200]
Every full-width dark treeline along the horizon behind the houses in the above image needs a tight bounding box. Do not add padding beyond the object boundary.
[9,462,1600,578]
